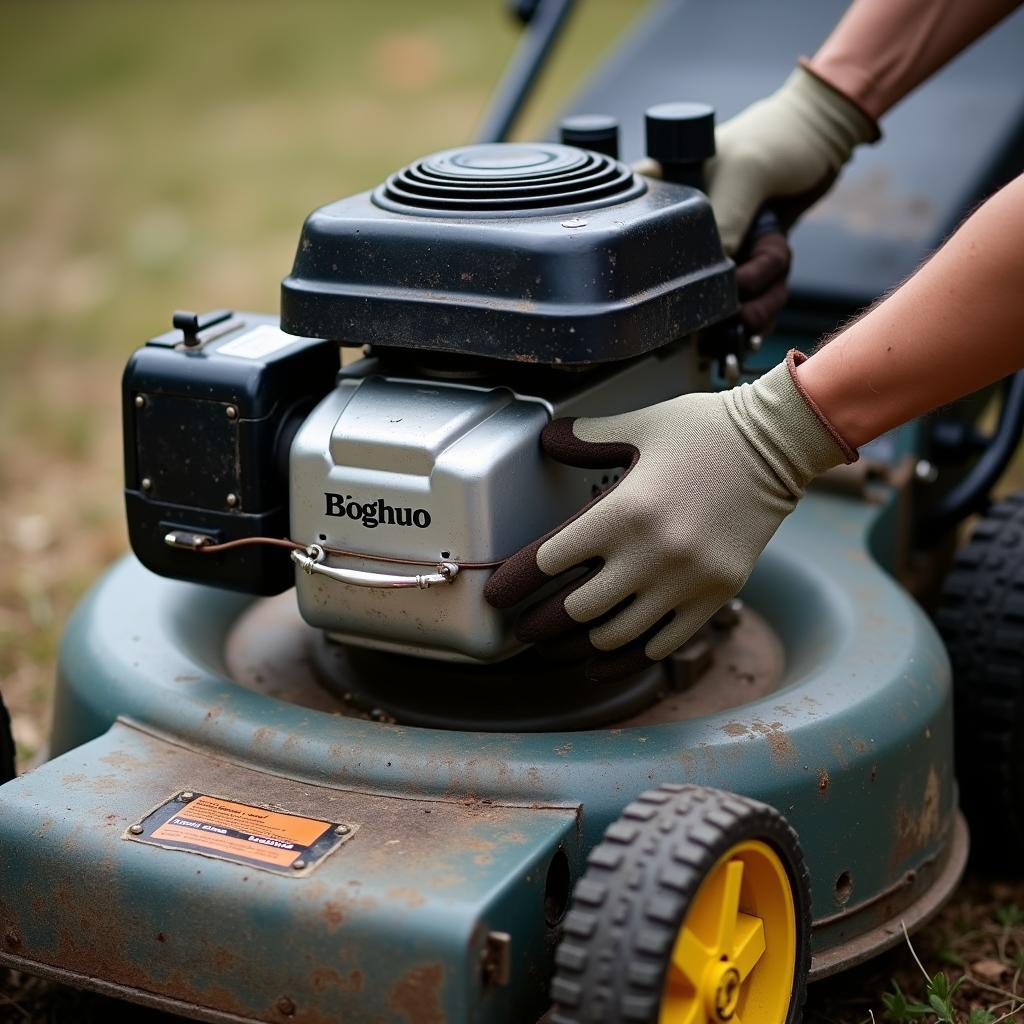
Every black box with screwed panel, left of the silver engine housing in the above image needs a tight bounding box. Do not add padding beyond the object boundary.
[122,309,340,595]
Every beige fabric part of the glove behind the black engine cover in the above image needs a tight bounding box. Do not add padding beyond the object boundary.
[705,67,880,256]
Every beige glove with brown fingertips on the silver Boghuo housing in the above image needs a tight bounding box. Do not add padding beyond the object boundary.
[484,352,856,682]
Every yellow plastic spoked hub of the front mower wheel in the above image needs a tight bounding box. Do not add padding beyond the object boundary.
[658,840,797,1024]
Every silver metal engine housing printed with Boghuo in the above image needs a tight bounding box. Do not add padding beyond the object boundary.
[290,341,709,662]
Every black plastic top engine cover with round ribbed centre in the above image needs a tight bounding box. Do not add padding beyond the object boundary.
[281,142,736,366]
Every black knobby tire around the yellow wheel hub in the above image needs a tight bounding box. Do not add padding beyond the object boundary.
[550,784,811,1024]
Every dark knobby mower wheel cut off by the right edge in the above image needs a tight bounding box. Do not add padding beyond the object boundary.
[936,494,1024,873]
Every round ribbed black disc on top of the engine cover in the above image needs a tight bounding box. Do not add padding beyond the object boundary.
[374,143,644,216]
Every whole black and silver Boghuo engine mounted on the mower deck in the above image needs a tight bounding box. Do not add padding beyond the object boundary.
[124,104,736,720]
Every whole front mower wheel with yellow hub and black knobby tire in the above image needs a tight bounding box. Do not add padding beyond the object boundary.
[550,785,811,1024]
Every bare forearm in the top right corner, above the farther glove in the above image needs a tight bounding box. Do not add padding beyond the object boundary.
[808,0,1021,119]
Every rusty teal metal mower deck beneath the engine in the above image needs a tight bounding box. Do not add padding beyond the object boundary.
[0,483,967,1022]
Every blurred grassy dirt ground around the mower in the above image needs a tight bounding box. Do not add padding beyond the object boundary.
[0,0,1024,1024]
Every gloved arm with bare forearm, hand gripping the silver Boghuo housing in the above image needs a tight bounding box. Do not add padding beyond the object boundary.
[485,177,1024,680]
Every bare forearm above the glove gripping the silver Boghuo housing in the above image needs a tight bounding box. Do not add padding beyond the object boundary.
[798,175,1024,447]
